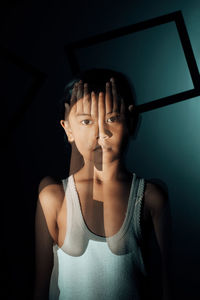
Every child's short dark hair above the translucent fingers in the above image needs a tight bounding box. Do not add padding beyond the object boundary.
[60,68,135,120]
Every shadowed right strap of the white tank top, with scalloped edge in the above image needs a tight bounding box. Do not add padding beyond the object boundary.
[133,178,145,241]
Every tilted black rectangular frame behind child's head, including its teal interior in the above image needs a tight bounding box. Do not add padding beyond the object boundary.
[65,11,200,113]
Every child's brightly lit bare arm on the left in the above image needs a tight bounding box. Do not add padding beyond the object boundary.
[33,179,59,300]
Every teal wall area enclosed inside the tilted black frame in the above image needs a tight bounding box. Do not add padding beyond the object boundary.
[76,22,194,105]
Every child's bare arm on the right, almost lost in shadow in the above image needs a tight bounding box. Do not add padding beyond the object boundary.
[145,183,172,300]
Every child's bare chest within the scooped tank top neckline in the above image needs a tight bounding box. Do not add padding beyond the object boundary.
[76,183,130,237]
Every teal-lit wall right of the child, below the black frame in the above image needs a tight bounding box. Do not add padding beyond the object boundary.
[128,98,200,299]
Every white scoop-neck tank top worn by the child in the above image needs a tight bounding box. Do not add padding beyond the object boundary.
[49,174,146,300]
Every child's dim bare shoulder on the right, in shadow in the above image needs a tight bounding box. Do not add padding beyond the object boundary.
[144,181,168,216]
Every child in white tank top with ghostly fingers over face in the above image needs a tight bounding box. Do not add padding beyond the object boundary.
[34,69,171,300]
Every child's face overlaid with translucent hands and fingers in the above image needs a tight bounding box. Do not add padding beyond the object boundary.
[63,80,133,163]
